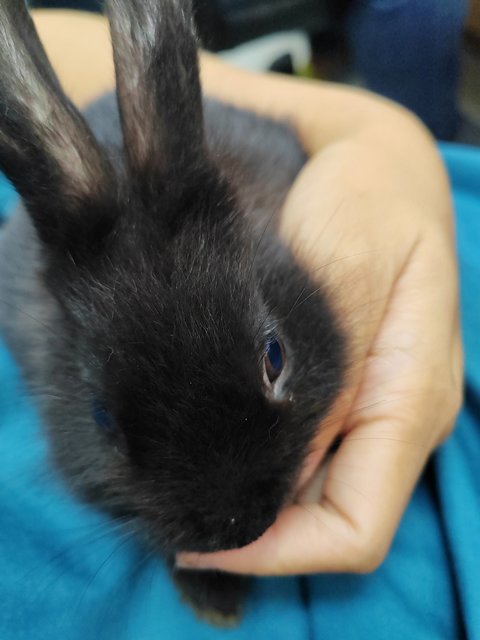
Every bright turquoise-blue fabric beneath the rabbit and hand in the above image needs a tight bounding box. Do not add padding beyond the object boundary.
[0,146,480,640]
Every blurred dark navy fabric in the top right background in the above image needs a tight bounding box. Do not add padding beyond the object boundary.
[347,0,469,140]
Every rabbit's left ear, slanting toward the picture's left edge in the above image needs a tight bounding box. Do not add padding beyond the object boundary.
[0,0,114,245]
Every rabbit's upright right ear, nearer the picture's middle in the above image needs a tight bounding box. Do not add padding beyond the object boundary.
[107,0,203,198]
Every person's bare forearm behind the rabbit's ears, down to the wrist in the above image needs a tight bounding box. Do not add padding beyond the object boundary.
[35,11,448,215]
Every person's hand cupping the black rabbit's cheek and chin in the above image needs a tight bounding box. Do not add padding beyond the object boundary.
[177,110,462,575]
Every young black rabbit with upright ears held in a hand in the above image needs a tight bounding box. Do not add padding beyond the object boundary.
[0,0,345,623]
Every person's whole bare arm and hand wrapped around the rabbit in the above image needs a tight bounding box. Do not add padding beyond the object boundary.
[32,11,463,575]
